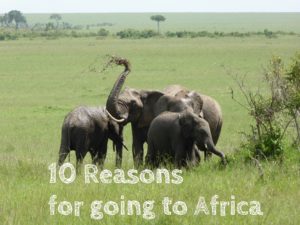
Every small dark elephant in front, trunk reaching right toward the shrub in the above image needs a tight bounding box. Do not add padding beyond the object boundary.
[146,110,225,168]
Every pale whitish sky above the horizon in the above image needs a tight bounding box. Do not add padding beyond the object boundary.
[0,0,300,13]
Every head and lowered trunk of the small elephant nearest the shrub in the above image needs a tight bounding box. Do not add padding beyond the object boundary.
[179,111,225,163]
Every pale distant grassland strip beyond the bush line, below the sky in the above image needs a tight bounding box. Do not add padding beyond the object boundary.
[26,13,300,33]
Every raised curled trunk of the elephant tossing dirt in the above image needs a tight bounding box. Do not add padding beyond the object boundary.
[106,58,130,122]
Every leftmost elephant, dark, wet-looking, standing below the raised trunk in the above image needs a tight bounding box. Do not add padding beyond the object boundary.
[58,106,126,169]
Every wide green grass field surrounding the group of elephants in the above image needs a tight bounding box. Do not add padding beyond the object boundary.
[0,14,300,224]
